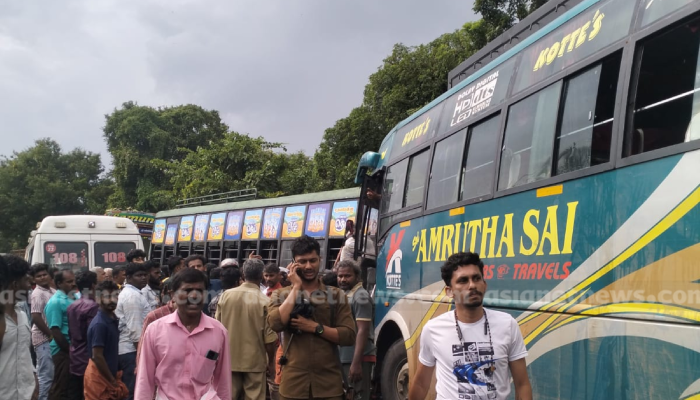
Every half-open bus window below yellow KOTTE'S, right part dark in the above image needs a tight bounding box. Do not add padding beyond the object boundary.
[555,53,620,175]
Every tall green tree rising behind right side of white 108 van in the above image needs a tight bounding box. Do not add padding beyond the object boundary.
[103,102,228,212]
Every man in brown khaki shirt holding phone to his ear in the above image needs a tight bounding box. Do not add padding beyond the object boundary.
[268,236,355,399]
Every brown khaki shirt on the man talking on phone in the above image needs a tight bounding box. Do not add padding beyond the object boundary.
[268,282,356,399]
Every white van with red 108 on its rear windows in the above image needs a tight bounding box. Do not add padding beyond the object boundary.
[25,215,144,271]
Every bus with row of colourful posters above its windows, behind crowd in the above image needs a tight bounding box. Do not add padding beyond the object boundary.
[150,188,360,268]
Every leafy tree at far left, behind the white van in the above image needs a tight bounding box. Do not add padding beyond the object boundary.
[0,139,113,252]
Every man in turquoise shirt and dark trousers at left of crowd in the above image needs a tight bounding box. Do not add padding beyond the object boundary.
[44,270,77,399]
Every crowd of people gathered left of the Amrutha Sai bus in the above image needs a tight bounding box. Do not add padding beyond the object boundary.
[0,236,376,400]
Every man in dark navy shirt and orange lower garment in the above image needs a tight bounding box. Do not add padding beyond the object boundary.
[83,281,126,400]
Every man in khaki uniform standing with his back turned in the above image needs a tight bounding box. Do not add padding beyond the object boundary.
[216,259,277,400]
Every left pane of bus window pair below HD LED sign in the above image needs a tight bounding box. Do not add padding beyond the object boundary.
[426,129,467,209]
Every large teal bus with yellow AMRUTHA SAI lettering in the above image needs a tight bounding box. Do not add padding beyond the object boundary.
[356,0,700,400]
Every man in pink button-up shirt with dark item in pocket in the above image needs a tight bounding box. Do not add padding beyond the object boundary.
[134,268,231,400]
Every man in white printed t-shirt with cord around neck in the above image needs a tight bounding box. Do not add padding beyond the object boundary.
[408,253,532,400]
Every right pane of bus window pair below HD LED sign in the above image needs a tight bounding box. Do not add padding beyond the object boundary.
[459,114,500,200]
